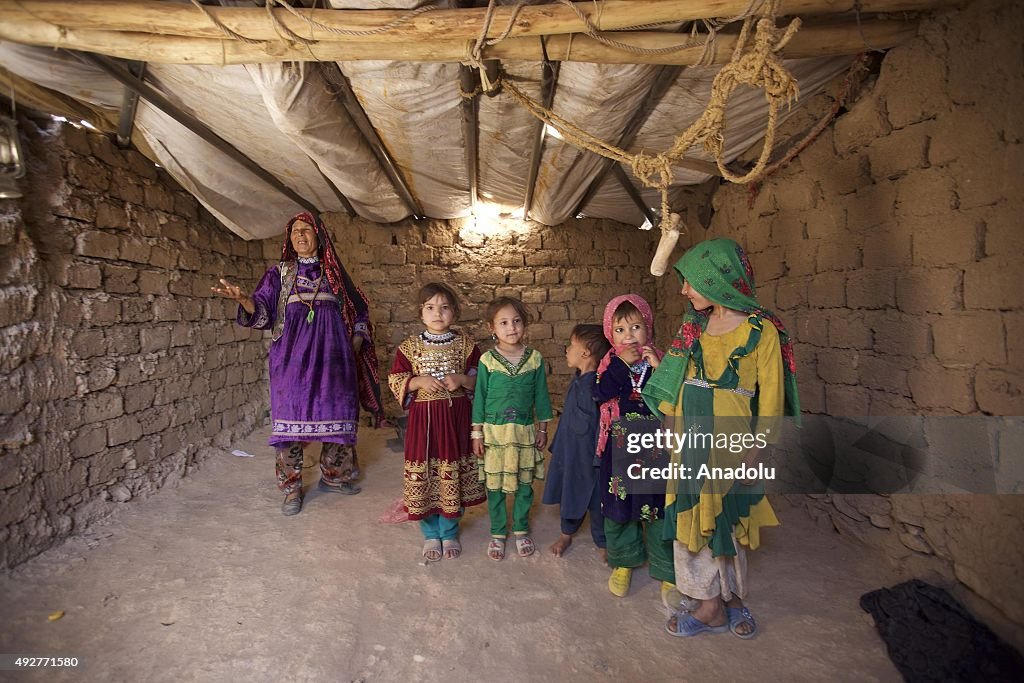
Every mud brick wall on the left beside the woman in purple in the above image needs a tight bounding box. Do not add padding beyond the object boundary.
[0,119,267,566]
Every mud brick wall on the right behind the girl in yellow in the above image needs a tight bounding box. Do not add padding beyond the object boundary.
[658,0,1024,643]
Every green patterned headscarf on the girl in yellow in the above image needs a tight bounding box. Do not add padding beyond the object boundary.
[643,238,800,422]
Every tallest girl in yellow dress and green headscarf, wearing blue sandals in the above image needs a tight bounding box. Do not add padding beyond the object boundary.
[643,239,800,639]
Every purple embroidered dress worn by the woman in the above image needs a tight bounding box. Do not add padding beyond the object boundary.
[238,257,369,446]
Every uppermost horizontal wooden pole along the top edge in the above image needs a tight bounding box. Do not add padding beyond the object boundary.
[0,0,965,45]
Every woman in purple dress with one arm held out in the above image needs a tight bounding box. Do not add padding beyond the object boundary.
[212,213,381,515]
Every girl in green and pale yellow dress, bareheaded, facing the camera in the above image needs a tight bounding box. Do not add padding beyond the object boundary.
[470,297,552,560]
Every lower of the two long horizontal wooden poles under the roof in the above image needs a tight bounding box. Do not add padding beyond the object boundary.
[0,19,918,66]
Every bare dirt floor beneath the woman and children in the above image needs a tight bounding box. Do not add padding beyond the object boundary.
[0,429,900,682]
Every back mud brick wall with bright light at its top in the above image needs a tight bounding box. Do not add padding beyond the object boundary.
[247,214,657,415]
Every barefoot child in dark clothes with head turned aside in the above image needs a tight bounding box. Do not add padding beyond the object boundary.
[543,325,611,557]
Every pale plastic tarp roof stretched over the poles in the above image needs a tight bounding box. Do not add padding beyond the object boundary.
[0,0,851,239]
